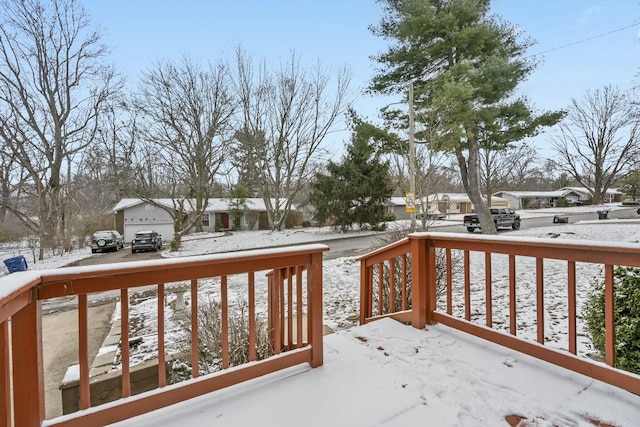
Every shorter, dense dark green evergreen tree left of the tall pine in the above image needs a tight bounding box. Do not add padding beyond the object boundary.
[310,116,391,232]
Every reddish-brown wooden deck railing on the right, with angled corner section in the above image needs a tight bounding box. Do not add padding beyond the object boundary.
[360,233,640,394]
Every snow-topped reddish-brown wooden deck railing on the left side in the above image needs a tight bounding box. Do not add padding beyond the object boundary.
[0,245,328,427]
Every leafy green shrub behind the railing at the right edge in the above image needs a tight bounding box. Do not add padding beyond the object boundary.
[582,267,640,374]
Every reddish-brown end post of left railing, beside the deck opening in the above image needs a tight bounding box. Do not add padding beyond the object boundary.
[307,252,323,368]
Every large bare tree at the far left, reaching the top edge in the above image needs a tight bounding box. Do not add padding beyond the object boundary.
[0,0,121,257]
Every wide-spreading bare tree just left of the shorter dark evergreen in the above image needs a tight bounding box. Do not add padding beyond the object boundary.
[236,48,350,230]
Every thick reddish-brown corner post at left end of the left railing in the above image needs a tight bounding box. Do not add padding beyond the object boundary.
[11,299,44,427]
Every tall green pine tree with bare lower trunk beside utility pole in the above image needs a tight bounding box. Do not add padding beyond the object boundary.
[370,0,562,233]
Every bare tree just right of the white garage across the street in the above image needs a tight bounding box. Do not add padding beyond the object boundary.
[138,57,236,239]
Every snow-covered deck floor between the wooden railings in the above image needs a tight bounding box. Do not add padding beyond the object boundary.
[111,319,640,427]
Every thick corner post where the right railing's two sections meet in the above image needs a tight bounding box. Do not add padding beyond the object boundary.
[408,235,430,329]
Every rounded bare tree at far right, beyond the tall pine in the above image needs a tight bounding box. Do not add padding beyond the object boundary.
[553,85,640,204]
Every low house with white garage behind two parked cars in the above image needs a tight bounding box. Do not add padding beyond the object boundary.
[112,198,290,241]
